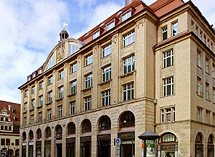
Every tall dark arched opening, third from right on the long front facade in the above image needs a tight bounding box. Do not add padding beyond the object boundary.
[80,119,92,157]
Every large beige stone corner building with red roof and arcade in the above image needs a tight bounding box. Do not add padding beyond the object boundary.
[19,0,215,157]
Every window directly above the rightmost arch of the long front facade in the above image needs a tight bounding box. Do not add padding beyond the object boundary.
[123,82,134,101]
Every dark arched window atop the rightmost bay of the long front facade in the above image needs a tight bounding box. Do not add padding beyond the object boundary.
[119,111,135,128]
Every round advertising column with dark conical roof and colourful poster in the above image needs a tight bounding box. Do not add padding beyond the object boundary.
[138,130,160,157]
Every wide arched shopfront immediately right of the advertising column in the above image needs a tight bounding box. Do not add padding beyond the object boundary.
[158,133,178,157]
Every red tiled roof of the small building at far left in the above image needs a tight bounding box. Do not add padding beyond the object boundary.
[0,100,21,126]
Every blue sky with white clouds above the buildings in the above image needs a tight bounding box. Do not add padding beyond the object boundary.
[0,0,215,103]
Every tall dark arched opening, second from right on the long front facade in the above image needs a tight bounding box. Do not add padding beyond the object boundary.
[97,116,111,157]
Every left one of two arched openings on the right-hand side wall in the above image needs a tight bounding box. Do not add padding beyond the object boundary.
[195,132,204,157]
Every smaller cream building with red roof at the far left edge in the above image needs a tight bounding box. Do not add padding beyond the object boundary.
[0,100,21,157]
